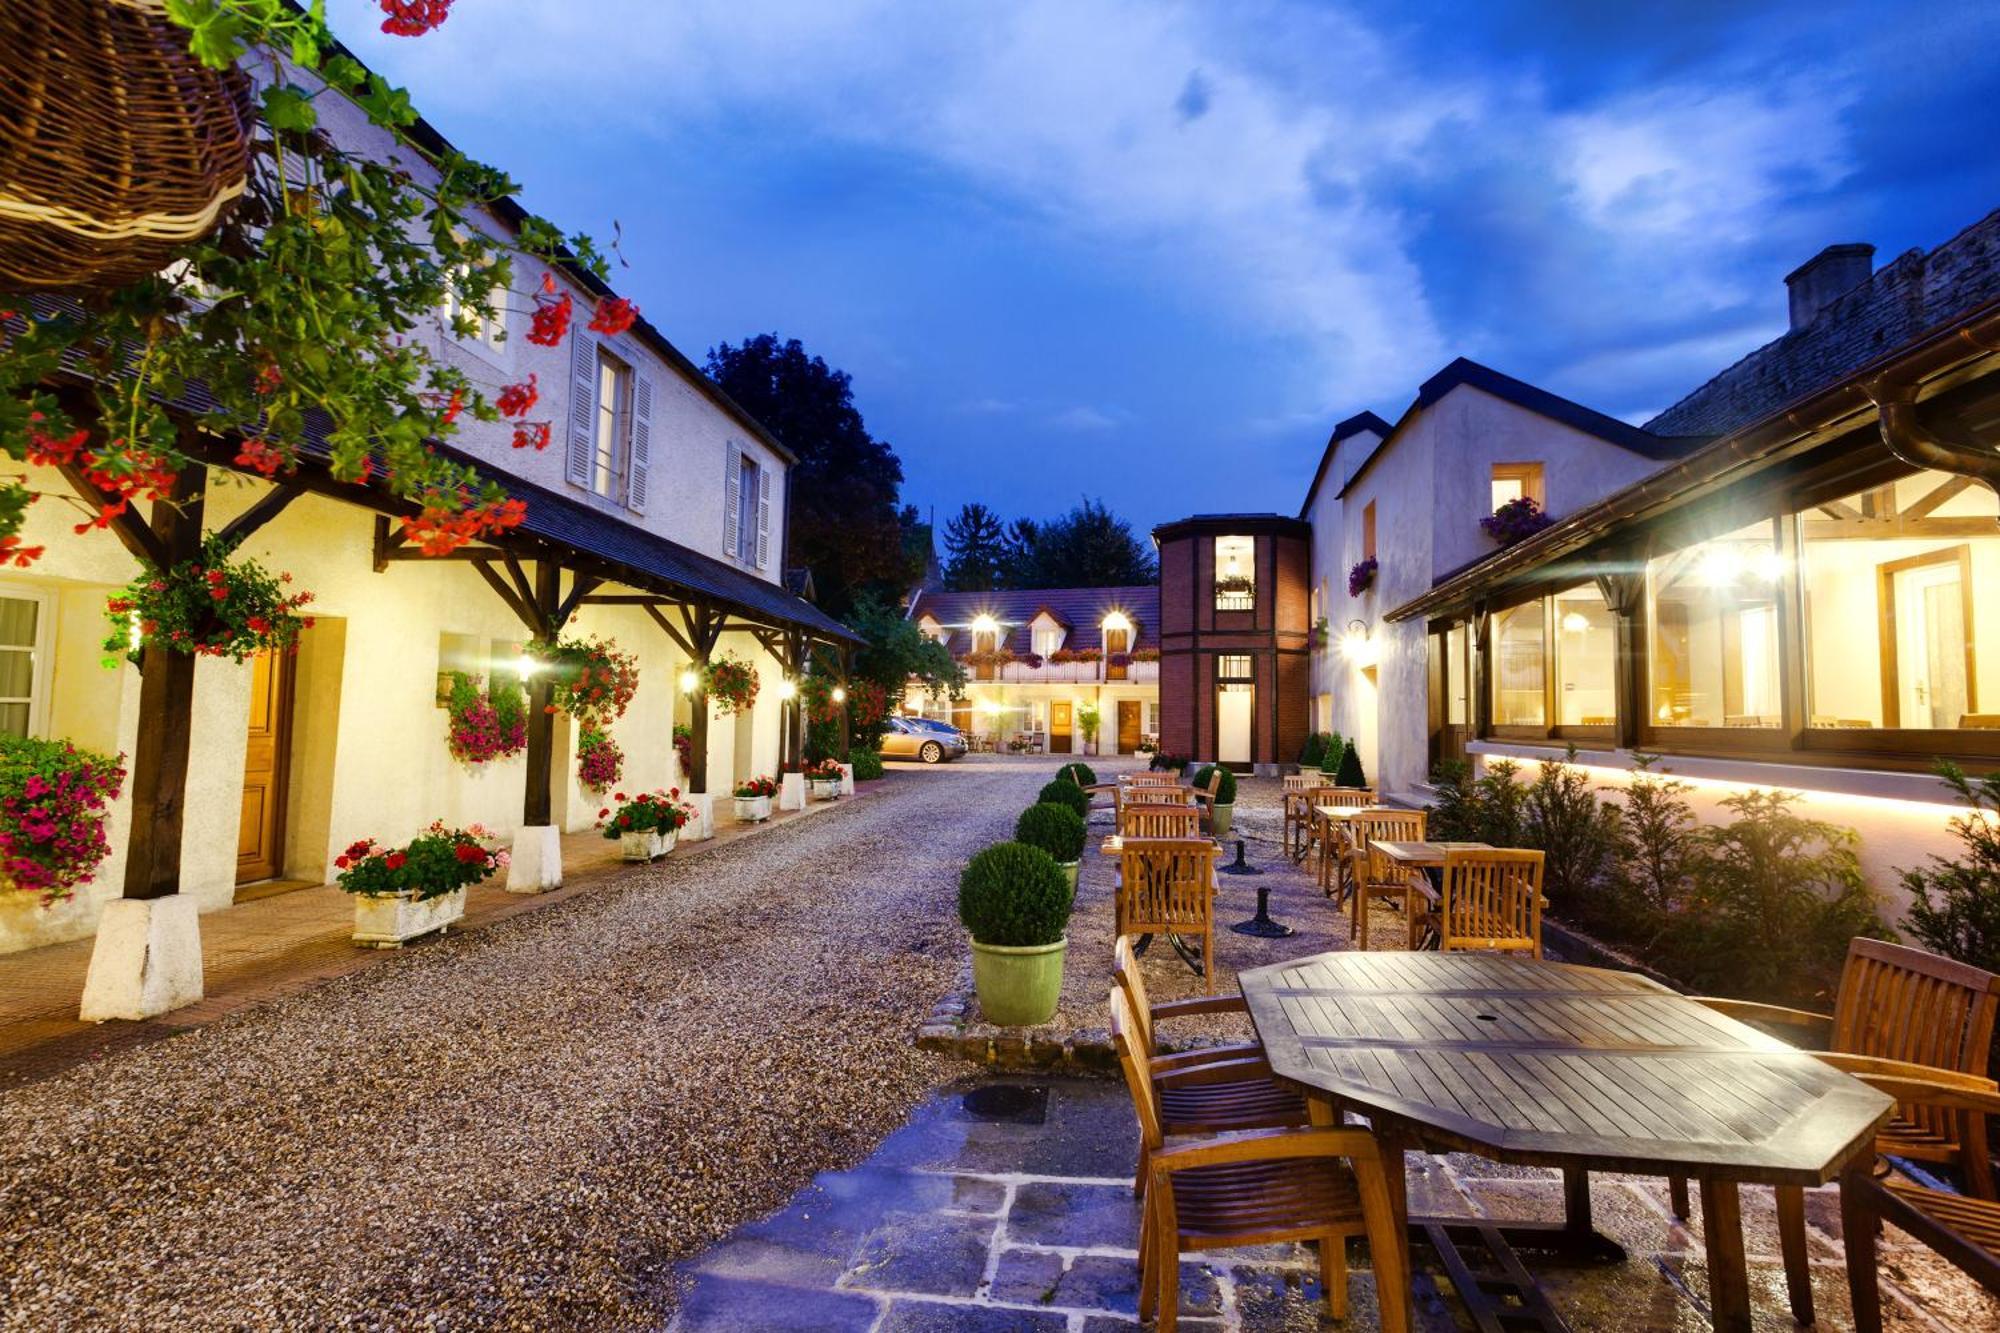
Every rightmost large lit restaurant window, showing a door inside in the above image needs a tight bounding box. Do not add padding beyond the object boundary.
[1798,472,2000,731]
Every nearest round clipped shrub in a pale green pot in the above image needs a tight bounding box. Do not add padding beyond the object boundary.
[958,843,1076,1027]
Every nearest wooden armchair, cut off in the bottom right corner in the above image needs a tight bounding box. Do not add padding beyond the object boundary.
[1832,1069,2000,1333]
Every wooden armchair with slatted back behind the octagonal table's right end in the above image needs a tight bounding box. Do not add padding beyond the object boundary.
[1672,939,2000,1217]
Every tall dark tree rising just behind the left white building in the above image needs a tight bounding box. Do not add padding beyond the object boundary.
[706,334,920,616]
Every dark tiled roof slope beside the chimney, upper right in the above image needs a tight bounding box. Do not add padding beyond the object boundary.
[1646,210,2000,434]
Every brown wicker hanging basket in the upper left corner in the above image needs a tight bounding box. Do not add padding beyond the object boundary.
[0,0,250,288]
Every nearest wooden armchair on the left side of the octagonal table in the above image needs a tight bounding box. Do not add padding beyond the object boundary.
[1112,991,1410,1333]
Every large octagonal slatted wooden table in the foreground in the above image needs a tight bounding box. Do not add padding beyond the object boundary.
[1238,951,1894,1333]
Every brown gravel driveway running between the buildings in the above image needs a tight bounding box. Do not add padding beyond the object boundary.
[0,761,1056,1329]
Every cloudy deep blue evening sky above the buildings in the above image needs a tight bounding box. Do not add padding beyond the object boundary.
[348,0,2000,524]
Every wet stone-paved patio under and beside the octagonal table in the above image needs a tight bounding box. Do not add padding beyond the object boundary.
[670,1075,2000,1333]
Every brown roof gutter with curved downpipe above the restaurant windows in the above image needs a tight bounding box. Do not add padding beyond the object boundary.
[1382,300,2000,622]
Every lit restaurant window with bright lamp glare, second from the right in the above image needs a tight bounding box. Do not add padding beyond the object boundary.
[1646,518,1784,729]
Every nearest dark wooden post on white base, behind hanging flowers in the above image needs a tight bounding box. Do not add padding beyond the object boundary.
[124,464,208,899]
